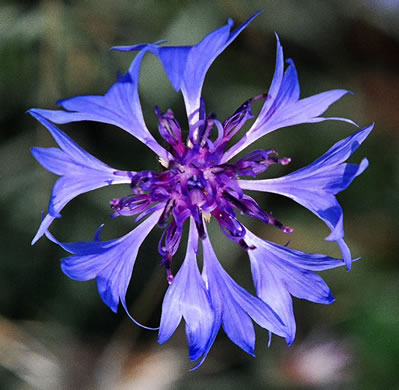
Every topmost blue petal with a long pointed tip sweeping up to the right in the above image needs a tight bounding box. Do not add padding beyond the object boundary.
[114,11,261,123]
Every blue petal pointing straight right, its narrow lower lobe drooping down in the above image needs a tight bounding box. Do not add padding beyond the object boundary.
[239,125,373,270]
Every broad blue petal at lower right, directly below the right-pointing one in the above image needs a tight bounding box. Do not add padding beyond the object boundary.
[245,229,345,344]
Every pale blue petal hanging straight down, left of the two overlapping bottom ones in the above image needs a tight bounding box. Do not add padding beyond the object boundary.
[158,219,214,361]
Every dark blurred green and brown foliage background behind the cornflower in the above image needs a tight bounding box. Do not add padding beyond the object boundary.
[0,0,399,390]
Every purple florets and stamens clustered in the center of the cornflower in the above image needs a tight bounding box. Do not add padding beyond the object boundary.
[110,95,292,282]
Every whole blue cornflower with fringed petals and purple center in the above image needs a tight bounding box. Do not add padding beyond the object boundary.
[29,10,373,367]
